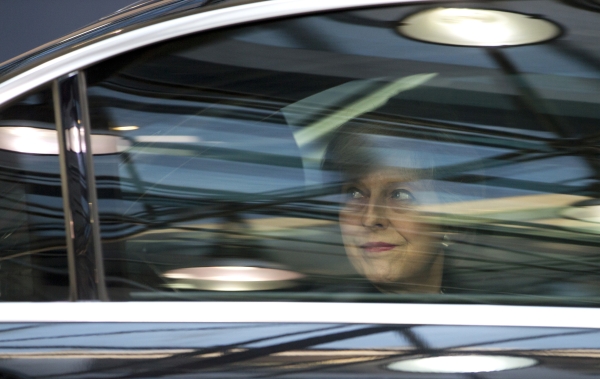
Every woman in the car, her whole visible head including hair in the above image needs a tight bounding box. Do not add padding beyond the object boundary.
[326,124,444,293]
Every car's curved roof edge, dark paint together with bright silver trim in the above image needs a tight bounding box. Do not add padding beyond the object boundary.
[0,0,418,105]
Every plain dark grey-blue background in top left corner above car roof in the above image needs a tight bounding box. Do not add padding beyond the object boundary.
[0,0,136,63]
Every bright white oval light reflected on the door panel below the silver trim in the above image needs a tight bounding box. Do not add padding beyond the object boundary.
[387,355,537,374]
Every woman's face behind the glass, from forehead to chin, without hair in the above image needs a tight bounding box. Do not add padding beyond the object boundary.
[340,168,443,292]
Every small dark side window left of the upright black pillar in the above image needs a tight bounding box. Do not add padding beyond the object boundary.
[0,87,69,301]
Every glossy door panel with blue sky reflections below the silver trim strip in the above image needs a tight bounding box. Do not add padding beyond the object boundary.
[0,323,600,378]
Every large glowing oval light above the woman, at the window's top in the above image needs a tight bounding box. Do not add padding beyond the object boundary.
[397,8,561,47]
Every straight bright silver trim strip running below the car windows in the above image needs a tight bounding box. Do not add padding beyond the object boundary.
[0,301,600,329]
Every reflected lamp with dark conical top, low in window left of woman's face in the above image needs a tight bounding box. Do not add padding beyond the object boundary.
[163,212,304,291]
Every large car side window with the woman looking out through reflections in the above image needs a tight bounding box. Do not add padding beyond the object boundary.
[87,1,600,305]
